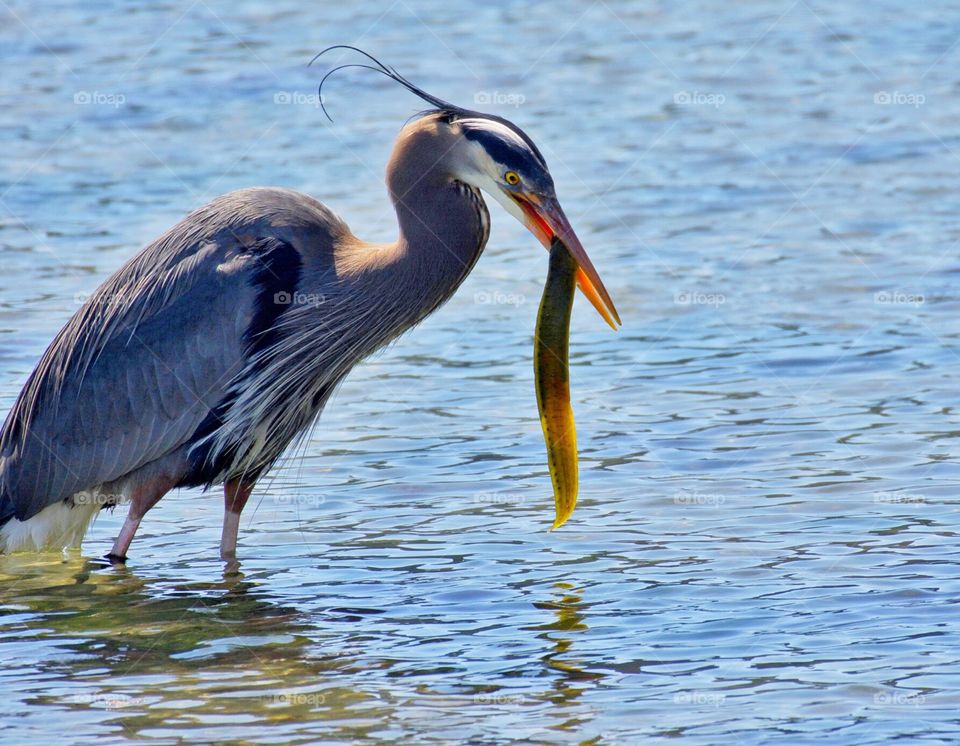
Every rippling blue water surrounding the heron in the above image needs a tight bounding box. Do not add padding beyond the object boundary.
[0,0,960,744]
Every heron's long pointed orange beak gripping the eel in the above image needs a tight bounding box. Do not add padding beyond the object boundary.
[510,192,621,331]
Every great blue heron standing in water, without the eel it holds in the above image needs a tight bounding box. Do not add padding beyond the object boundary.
[0,49,619,561]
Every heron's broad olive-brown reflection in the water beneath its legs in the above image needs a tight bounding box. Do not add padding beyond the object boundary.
[0,555,394,737]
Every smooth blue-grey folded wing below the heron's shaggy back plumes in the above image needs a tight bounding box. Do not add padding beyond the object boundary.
[4,238,252,520]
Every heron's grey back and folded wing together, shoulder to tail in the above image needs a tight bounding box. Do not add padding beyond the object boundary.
[0,189,347,520]
